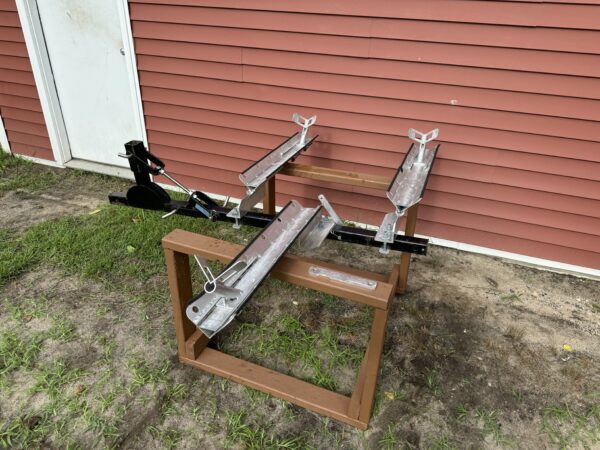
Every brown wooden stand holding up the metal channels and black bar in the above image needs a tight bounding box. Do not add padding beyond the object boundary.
[163,163,417,429]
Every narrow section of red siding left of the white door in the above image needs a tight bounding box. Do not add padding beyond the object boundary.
[0,0,54,160]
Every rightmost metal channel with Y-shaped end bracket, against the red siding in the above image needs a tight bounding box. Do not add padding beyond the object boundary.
[375,128,439,254]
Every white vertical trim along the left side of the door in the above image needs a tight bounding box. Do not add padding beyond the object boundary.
[16,0,71,165]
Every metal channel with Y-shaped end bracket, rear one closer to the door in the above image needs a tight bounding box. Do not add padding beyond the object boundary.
[227,114,317,228]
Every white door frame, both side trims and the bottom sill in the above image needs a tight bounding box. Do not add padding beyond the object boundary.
[16,0,148,175]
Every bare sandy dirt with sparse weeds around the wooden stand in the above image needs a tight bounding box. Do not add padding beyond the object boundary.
[0,163,600,449]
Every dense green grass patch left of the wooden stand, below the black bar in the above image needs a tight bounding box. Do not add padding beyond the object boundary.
[0,205,232,289]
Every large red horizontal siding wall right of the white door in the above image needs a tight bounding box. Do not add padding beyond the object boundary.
[129,0,600,268]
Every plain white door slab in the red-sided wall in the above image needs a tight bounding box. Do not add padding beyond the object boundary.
[37,0,143,166]
